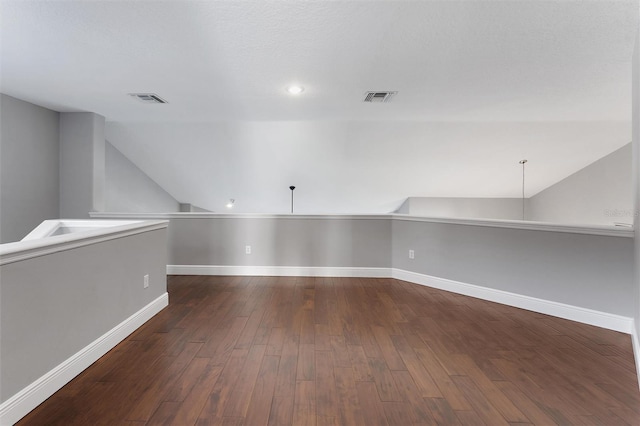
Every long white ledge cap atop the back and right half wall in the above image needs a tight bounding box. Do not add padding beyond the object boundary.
[90,212,634,238]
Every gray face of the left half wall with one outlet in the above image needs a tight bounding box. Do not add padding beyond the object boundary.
[0,229,167,402]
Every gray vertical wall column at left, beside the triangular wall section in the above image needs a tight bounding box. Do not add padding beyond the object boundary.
[60,112,105,219]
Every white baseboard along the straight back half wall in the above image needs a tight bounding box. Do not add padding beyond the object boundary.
[167,265,391,278]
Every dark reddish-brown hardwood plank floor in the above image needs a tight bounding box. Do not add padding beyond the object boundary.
[19,276,640,426]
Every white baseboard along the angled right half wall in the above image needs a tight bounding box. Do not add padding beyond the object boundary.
[392,268,640,336]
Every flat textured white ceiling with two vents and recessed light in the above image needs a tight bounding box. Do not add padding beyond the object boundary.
[1,0,638,121]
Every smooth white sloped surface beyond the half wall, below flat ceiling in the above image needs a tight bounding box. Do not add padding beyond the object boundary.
[106,121,631,214]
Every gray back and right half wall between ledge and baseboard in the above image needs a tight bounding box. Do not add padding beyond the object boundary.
[97,213,634,317]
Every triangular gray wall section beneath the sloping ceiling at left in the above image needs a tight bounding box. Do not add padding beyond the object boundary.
[105,141,179,212]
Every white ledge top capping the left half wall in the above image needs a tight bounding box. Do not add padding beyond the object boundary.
[0,219,169,265]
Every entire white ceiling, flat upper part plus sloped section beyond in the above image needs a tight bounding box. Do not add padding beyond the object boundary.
[0,0,639,212]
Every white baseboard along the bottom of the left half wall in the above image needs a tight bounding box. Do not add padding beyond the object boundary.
[0,293,169,426]
